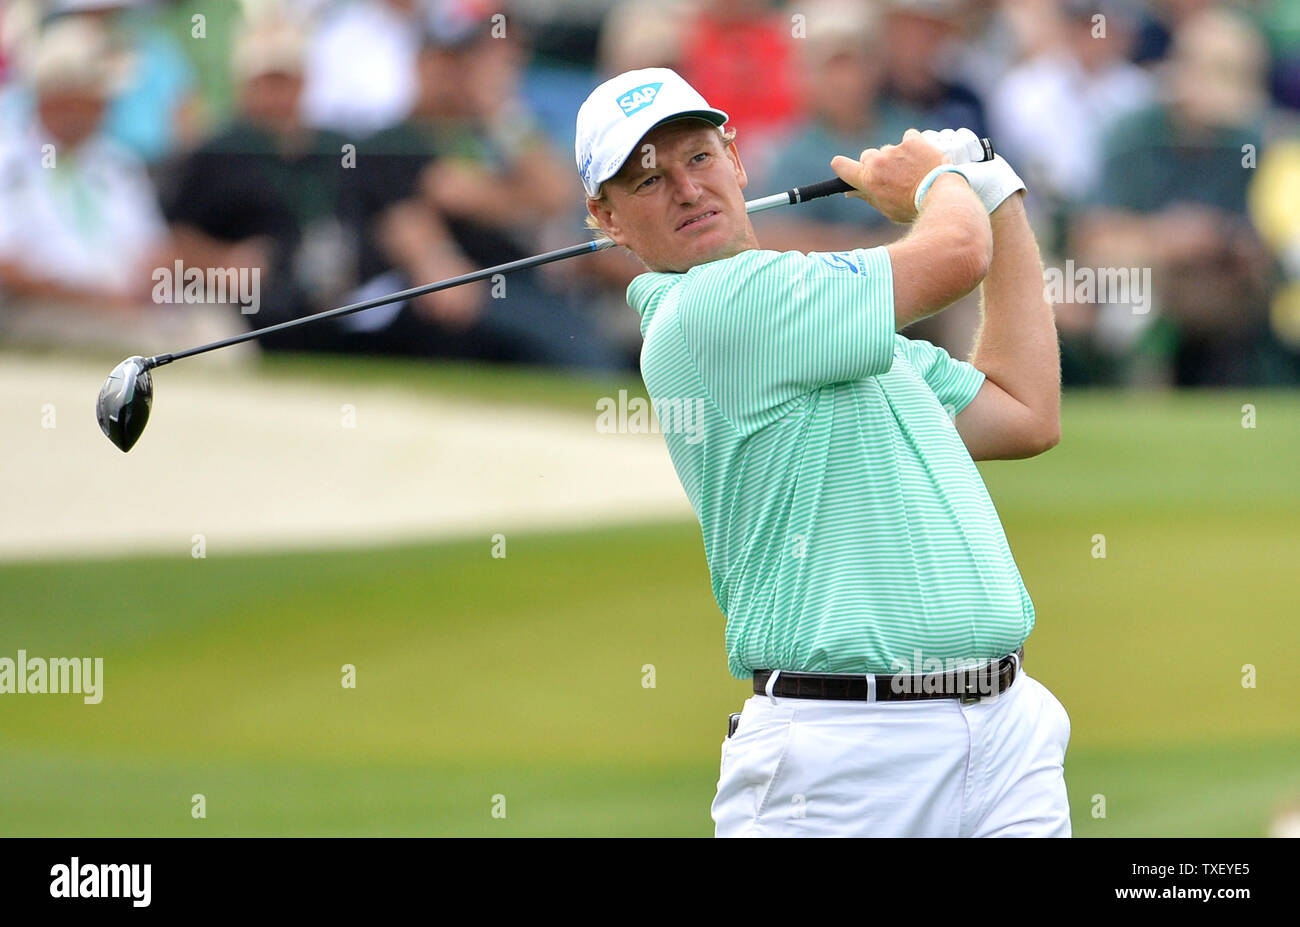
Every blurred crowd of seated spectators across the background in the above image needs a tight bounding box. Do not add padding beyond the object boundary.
[0,0,1300,385]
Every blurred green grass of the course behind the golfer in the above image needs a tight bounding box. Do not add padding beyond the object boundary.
[0,382,1300,836]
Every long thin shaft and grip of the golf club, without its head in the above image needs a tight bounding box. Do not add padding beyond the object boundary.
[144,147,992,369]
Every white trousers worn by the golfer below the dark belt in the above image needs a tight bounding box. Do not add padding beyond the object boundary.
[712,670,1070,837]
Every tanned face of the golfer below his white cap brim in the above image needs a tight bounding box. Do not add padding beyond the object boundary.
[593,120,755,272]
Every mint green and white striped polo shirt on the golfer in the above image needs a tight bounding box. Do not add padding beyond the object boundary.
[628,247,1034,679]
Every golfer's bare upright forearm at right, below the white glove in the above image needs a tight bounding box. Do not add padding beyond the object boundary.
[971,194,1061,432]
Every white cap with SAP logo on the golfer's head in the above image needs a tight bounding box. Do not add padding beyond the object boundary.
[575,68,727,196]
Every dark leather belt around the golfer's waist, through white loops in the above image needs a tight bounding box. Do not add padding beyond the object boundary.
[754,647,1024,703]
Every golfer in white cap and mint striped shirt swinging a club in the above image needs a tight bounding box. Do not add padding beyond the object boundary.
[576,69,1070,836]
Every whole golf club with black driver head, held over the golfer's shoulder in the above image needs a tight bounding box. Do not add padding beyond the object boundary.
[95,139,993,452]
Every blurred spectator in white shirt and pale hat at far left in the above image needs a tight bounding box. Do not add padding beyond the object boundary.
[0,14,248,363]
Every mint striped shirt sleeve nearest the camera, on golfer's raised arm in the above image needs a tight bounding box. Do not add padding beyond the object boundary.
[677,247,894,433]
